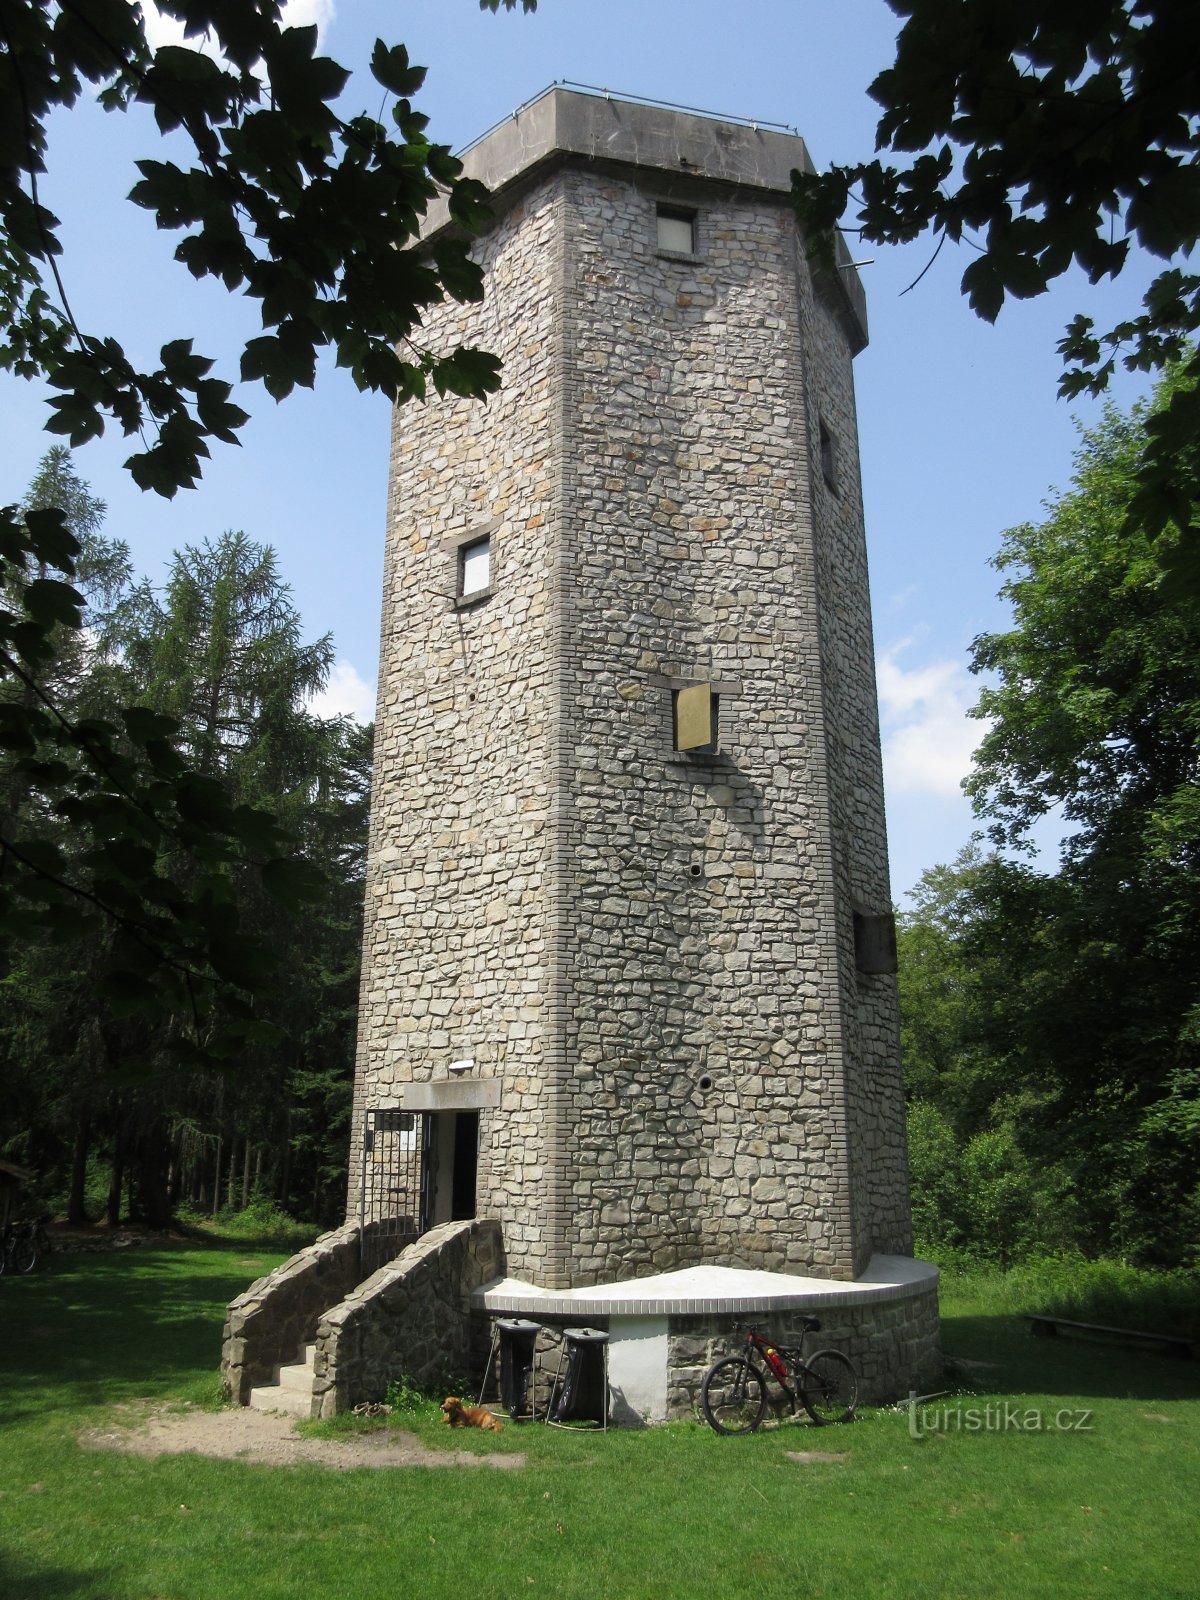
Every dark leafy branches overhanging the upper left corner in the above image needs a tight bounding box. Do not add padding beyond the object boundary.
[0,0,499,496]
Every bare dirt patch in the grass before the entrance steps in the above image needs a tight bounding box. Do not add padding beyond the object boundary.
[80,1406,525,1472]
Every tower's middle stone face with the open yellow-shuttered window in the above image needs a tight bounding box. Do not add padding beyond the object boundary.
[563,162,899,1283]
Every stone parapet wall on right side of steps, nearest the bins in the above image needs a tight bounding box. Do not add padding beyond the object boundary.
[312,1218,504,1416]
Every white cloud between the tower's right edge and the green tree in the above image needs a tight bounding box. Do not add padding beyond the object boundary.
[875,638,986,798]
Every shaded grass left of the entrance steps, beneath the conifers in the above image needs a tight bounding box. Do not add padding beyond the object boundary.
[0,1250,267,1420]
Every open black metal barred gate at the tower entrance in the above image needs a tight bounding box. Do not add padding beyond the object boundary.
[358,1106,434,1277]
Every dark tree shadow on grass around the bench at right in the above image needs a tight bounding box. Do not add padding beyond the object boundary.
[942,1312,1200,1400]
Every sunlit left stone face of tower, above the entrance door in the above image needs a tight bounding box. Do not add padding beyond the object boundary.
[349,189,558,1275]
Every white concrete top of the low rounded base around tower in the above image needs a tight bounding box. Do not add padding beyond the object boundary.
[472,1256,938,1320]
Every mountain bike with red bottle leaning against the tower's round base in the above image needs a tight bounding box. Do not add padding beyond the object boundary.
[701,1317,858,1434]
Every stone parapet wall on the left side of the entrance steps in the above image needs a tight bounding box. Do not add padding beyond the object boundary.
[221,1222,366,1405]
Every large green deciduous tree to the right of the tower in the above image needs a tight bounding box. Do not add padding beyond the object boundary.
[899,379,1200,1262]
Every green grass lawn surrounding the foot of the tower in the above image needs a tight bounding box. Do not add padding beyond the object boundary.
[0,1245,1200,1600]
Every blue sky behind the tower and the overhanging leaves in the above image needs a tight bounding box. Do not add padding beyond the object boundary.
[0,0,1149,899]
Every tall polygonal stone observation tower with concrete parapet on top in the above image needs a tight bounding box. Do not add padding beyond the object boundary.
[336,88,936,1414]
